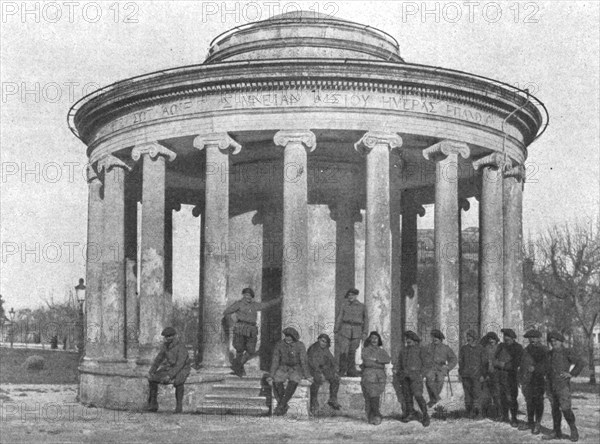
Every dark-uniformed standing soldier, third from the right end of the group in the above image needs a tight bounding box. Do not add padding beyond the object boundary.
[494,328,523,427]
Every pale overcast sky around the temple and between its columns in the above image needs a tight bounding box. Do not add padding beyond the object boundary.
[0,1,600,309]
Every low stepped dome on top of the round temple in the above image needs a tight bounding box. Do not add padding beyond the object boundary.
[204,11,404,64]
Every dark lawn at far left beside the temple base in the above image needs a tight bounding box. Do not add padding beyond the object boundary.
[0,347,80,384]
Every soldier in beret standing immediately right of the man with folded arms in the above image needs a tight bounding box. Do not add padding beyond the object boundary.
[394,330,431,427]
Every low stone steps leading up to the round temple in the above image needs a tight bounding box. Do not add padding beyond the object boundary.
[196,375,271,416]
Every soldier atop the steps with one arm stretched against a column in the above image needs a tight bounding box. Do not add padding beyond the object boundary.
[223,288,283,377]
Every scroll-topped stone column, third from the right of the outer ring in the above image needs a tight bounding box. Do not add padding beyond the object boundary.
[423,140,470,353]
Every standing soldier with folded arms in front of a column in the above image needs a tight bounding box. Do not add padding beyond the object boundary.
[360,331,391,425]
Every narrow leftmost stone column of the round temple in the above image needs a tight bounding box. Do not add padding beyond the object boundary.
[85,165,104,359]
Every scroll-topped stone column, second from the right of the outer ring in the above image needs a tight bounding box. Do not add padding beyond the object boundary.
[473,153,504,335]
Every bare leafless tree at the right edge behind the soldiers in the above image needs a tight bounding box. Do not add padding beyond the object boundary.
[529,222,600,384]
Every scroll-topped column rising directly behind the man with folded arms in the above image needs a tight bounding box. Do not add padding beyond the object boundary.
[354,131,402,353]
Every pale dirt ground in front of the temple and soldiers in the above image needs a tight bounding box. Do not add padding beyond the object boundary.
[0,384,600,444]
